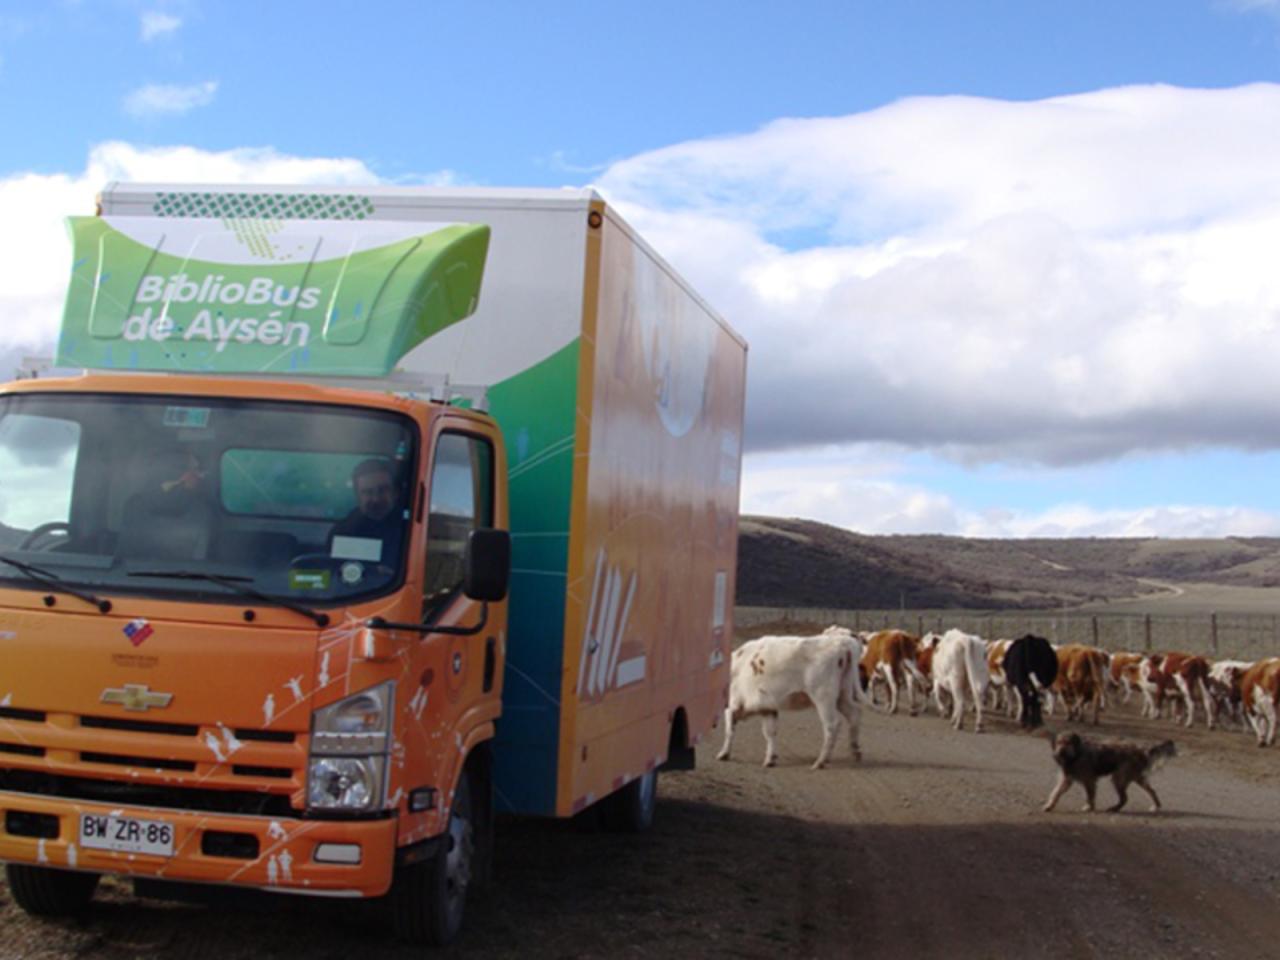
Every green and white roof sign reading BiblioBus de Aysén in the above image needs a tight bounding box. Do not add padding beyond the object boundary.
[55,216,489,376]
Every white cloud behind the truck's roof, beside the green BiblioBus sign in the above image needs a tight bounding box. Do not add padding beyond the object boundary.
[0,142,378,380]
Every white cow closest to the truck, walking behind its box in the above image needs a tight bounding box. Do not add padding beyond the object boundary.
[716,627,867,769]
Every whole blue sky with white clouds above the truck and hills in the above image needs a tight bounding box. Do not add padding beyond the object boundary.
[0,0,1280,538]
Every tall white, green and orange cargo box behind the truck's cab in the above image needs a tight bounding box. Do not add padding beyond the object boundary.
[59,184,745,815]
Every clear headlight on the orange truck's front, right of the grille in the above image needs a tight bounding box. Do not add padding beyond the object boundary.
[307,681,396,813]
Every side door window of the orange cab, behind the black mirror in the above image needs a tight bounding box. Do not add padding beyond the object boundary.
[422,433,493,618]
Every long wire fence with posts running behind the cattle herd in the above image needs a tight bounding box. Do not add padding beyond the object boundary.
[733,607,1280,660]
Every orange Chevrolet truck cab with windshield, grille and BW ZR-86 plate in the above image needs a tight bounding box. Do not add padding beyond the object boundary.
[0,374,507,938]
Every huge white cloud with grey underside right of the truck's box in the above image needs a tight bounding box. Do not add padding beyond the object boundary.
[598,84,1280,463]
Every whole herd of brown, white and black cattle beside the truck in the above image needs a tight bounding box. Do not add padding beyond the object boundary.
[718,626,1280,769]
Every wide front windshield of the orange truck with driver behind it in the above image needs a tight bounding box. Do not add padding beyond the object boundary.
[0,394,417,604]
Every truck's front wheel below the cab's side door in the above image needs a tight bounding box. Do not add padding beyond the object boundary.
[390,772,475,946]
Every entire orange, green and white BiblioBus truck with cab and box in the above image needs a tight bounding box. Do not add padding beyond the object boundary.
[0,184,746,943]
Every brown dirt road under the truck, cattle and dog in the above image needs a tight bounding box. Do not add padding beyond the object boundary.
[0,709,1280,960]
